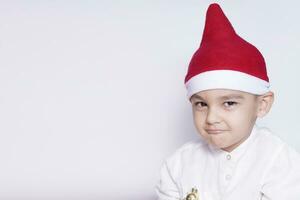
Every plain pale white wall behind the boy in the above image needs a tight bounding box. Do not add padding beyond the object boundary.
[0,0,300,200]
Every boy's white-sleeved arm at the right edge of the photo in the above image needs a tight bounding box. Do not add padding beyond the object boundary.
[262,145,300,200]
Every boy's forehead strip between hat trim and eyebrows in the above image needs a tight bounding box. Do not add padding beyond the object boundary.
[191,89,255,100]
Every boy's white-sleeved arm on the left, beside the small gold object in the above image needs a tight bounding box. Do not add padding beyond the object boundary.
[155,162,180,200]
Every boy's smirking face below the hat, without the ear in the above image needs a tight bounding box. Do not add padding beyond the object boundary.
[191,89,259,152]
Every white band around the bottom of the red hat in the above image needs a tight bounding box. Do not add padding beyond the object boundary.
[185,70,270,99]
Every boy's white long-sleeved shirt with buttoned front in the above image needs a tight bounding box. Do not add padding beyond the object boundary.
[156,125,300,200]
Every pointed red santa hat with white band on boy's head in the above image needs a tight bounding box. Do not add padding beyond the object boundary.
[184,3,270,98]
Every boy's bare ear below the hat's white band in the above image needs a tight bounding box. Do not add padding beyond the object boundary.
[257,91,274,117]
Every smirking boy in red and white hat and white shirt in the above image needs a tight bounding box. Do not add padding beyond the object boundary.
[156,4,300,200]
